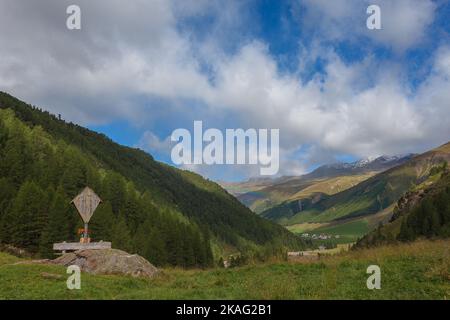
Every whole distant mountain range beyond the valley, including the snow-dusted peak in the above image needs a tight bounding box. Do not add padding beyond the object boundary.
[223,143,450,242]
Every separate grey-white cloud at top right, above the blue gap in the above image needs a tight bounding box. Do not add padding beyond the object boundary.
[299,0,437,52]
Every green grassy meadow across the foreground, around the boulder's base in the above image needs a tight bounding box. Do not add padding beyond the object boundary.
[0,240,450,299]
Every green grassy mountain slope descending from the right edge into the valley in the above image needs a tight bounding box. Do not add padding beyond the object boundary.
[261,143,450,225]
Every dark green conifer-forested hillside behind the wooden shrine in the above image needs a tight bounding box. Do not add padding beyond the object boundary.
[0,93,302,267]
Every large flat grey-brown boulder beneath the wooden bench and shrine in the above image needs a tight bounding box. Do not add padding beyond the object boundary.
[52,249,158,278]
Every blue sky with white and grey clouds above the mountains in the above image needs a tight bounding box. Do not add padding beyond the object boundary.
[0,0,450,181]
